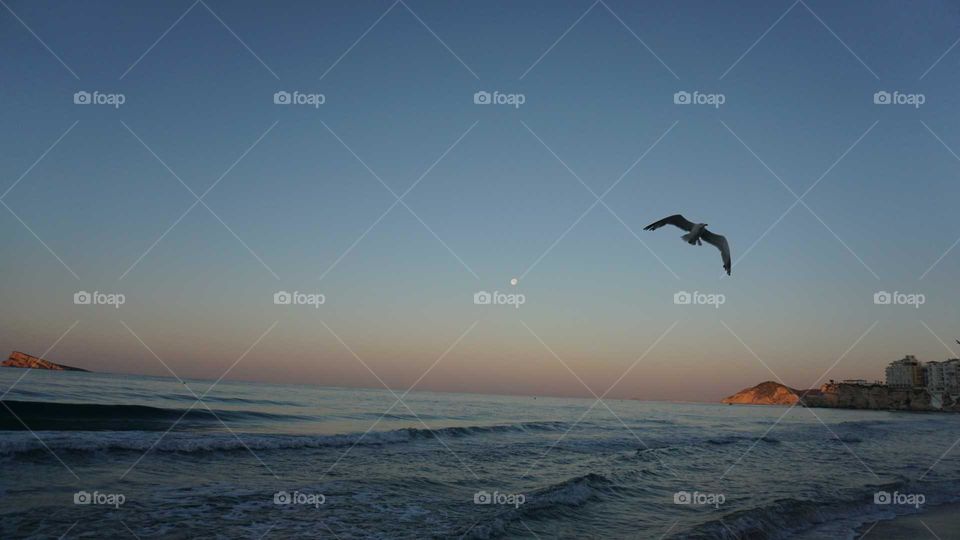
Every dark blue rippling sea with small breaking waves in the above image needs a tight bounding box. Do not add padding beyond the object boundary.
[0,368,960,539]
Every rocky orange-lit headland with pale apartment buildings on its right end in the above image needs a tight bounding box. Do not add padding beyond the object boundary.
[722,355,960,412]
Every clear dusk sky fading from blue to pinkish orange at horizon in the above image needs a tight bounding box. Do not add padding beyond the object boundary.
[0,0,960,401]
